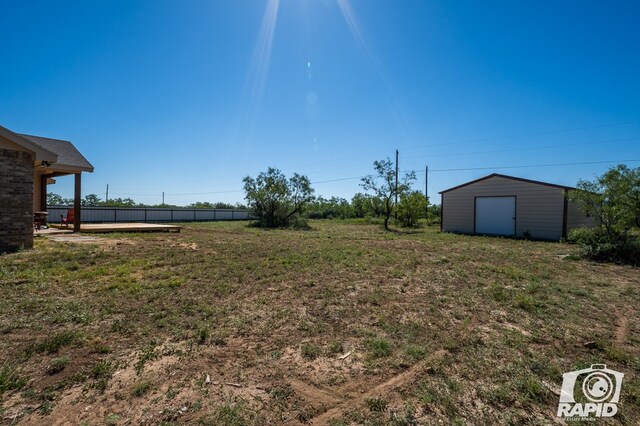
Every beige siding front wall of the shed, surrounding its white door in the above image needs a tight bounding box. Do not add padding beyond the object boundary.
[442,176,564,240]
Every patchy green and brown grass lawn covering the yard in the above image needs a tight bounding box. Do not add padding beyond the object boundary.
[0,221,640,425]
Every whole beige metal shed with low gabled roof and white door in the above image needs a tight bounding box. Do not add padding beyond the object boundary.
[440,173,598,241]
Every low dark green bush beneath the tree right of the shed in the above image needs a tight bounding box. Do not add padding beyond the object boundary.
[568,228,640,266]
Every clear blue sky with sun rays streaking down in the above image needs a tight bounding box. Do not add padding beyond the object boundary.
[0,0,640,204]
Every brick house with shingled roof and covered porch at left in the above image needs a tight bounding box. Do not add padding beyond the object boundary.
[0,126,93,252]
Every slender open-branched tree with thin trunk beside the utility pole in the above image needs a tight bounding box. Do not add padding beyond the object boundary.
[360,158,416,230]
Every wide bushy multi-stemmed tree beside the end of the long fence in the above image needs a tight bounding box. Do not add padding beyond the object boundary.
[242,167,313,228]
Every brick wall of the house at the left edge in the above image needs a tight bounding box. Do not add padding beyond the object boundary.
[0,149,33,252]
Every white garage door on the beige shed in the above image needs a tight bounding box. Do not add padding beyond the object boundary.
[476,197,516,236]
